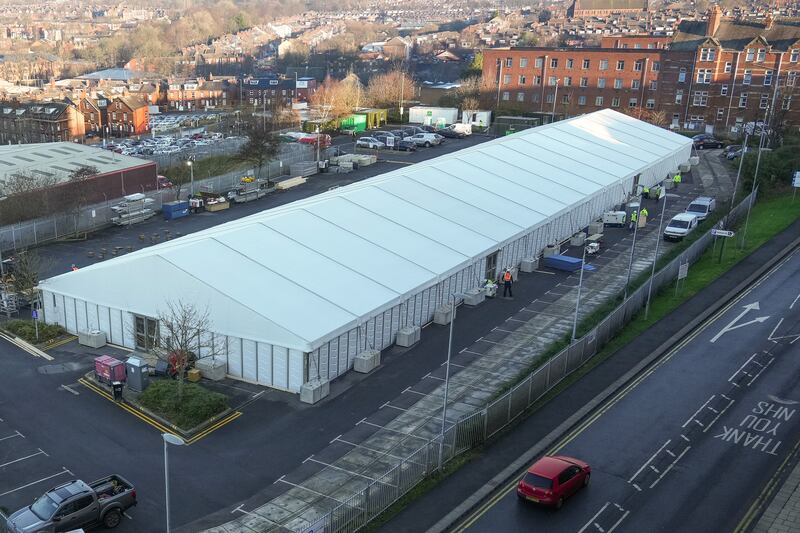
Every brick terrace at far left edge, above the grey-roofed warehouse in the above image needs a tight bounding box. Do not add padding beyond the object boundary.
[0,102,85,144]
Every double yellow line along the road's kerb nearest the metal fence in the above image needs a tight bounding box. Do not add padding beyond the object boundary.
[454,276,760,533]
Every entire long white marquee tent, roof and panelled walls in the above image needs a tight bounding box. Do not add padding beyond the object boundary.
[40,110,692,392]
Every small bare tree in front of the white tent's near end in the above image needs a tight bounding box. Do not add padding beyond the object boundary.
[155,300,222,401]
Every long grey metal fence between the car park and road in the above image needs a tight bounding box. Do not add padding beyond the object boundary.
[302,191,757,533]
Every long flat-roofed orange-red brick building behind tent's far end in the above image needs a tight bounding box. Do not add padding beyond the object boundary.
[483,48,664,116]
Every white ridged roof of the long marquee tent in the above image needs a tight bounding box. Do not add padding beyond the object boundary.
[42,110,691,351]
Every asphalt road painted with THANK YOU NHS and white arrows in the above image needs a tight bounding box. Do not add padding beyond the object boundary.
[456,245,800,532]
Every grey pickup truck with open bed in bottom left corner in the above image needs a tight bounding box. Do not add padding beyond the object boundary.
[6,475,136,533]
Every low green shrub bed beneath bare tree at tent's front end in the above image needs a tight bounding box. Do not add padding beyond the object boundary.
[138,379,228,430]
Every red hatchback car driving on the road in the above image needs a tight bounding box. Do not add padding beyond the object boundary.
[517,455,592,509]
